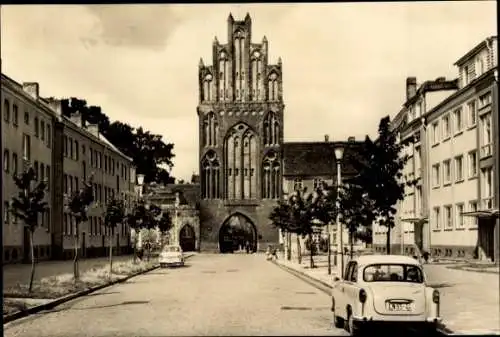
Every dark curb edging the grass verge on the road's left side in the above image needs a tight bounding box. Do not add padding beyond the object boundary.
[3,254,194,325]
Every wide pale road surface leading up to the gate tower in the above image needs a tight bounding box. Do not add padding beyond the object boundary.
[4,254,346,337]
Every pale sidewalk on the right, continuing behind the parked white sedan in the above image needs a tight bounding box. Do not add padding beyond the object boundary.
[276,255,500,334]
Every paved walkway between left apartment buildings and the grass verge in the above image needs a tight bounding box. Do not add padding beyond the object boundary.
[2,255,133,289]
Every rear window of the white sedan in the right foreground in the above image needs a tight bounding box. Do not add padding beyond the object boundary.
[363,263,424,283]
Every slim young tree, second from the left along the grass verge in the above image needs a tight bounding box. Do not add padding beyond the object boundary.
[68,176,94,282]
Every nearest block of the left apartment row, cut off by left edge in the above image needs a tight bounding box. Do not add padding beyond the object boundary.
[1,74,54,262]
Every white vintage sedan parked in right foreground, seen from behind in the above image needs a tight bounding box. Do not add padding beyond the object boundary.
[332,255,441,335]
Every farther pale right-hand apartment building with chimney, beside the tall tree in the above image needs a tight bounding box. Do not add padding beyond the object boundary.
[373,77,458,254]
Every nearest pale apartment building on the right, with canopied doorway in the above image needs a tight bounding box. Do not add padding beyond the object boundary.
[382,37,500,261]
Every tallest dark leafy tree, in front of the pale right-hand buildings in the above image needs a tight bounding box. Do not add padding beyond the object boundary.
[359,116,417,254]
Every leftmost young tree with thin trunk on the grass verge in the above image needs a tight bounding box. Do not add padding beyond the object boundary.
[12,167,48,293]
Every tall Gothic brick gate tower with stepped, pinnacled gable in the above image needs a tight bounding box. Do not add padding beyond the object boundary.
[197,14,284,251]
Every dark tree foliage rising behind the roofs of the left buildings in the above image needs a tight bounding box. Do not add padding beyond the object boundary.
[61,97,175,184]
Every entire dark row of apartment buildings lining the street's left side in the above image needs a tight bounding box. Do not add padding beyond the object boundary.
[2,74,135,262]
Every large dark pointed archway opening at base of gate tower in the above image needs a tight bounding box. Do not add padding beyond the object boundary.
[219,213,257,253]
